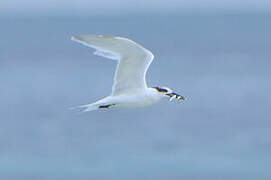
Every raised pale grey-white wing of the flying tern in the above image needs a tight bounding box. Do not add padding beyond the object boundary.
[72,35,154,95]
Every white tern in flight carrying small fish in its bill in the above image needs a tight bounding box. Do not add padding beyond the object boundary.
[71,35,186,112]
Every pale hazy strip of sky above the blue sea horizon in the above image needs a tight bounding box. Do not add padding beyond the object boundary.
[0,0,271,15]
